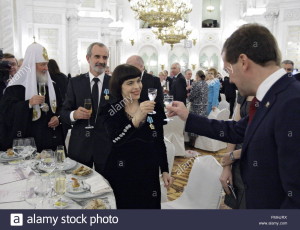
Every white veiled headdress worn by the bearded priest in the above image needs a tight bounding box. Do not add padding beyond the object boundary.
[8,42,56,121]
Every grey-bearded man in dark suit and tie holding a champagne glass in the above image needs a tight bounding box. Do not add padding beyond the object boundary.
[61,42,111,173]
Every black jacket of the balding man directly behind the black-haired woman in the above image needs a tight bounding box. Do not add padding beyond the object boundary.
[140,72,164,111]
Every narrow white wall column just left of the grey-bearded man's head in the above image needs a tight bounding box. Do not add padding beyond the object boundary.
[66,9,80,77]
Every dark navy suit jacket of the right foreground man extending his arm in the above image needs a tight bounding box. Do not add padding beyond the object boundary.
[185,74,300,209]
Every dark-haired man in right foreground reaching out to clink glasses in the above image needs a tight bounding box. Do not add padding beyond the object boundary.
[168,24,300,209]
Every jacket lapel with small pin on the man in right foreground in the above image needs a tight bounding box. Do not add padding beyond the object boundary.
[243,75,291,157]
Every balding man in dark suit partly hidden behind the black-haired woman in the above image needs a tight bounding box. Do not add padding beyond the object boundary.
[126,55,164,108]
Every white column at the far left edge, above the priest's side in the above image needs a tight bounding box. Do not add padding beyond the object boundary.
[0,0,15,54]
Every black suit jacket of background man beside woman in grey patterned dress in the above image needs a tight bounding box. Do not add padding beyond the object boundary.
[170,73,187,104]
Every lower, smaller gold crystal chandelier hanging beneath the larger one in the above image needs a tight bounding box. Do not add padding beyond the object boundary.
[152,20,192,49]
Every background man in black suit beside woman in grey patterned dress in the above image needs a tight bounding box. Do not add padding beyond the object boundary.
[170,63,187,104]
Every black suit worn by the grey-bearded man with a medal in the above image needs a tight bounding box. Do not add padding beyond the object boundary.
[61,73,112,173]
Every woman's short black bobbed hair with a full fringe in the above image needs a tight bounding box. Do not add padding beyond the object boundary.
[109,64,142,100]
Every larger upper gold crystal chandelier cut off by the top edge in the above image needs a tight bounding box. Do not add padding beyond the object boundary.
[128,0,192,31]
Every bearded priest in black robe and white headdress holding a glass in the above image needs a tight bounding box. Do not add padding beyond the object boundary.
[0,43,63,152]
